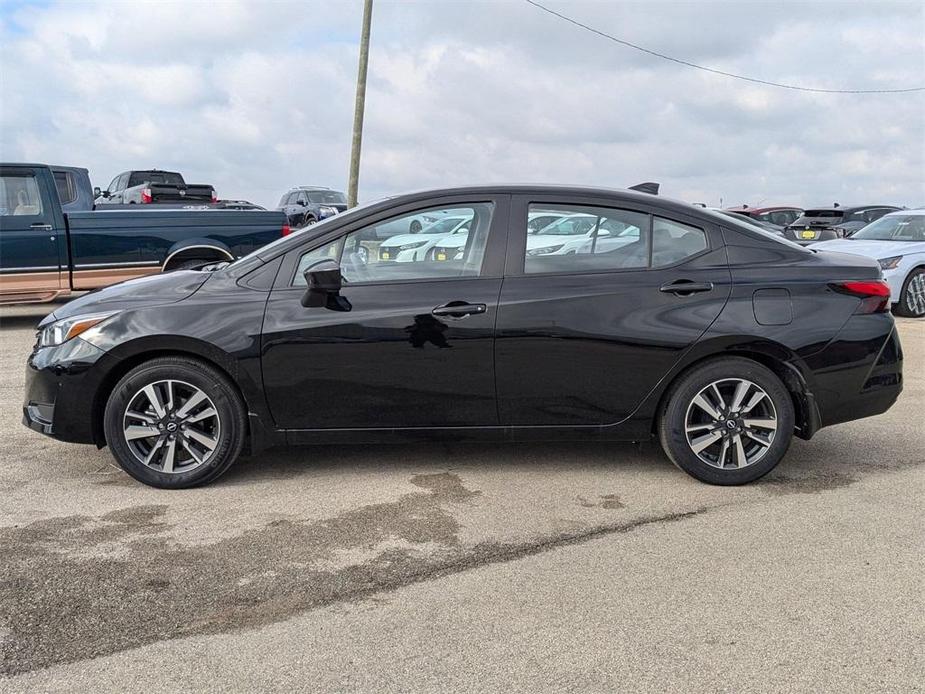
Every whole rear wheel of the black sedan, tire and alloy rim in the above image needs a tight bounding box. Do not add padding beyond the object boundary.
[659,357,794,485]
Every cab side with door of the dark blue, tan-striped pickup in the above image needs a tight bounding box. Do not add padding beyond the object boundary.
[0,166,67,300]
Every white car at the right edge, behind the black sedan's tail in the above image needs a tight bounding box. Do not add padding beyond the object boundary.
[810,209,925,318]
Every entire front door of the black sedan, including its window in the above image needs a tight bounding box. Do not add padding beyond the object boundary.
[263,195,510,429]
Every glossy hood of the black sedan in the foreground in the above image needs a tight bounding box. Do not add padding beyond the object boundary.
[40,270,212,325]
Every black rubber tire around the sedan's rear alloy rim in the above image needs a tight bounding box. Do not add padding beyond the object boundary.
[658,357,794,485]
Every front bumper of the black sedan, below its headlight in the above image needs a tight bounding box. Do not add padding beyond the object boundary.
[22,337,107,443]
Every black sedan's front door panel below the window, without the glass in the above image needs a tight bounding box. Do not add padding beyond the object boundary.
[263,278,501,429]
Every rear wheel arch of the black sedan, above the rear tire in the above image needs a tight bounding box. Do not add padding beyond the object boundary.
[652,338,821,446]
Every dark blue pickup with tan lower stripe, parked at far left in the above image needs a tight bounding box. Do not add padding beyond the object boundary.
[0,164,289,303]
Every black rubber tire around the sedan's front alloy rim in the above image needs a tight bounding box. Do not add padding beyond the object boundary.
[103,357,247,489]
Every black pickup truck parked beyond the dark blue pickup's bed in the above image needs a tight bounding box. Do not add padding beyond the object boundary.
[93,169,217,207]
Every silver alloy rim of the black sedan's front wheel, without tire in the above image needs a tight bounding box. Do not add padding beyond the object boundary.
[122,380,221,473]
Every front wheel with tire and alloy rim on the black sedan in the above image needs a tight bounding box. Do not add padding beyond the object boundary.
[103,357,247,489]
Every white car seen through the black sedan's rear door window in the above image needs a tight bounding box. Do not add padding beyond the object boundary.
[527,213,639,256]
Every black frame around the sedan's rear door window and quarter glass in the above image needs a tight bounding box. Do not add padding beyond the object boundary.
[504,194,723,277]
